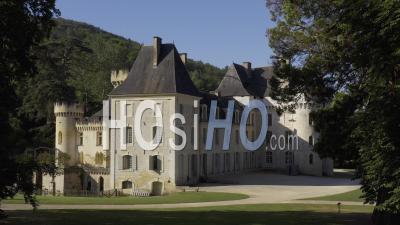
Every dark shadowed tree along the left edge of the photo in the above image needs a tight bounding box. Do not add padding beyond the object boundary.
[0,0,59,205]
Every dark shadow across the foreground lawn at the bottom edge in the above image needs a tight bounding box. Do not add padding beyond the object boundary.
[0,210,371,225]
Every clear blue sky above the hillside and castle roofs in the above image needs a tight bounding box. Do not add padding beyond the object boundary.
[57,0,274,67]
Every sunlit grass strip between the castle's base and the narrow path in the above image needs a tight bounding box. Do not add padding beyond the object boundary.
[2,192,249,205]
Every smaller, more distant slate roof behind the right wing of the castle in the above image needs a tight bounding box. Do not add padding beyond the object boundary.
[216,63,273,97]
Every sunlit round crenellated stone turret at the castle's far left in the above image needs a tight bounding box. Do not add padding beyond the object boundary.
[54,103,84,166]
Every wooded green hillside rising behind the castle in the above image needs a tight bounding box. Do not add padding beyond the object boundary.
[16,18,226,149]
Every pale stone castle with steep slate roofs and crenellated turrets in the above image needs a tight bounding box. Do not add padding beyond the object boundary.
[42,37,333,195]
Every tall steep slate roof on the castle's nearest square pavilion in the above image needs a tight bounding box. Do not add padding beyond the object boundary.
[110,44,199,96]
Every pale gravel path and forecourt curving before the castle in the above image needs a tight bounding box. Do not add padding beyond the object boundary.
[1,172,362,210]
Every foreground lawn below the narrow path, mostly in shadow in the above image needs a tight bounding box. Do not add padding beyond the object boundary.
[0,204,373,225]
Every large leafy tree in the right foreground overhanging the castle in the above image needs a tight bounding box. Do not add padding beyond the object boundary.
[267,0,400,224]
